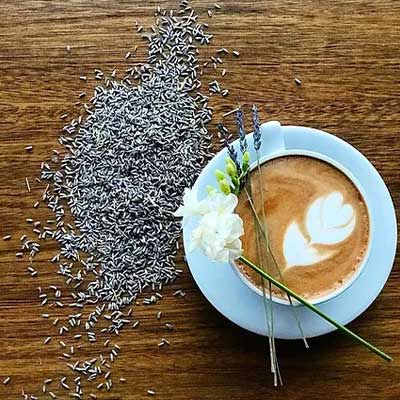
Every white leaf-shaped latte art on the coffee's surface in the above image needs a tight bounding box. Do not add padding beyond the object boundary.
[283,192,356,267]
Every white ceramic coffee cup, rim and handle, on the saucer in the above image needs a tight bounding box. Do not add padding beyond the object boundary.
[232,121,374,305]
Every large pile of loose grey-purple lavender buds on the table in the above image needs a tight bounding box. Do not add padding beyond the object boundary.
[14,0,222,399]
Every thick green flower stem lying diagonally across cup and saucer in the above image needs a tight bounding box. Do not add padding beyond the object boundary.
[239,256,392,361]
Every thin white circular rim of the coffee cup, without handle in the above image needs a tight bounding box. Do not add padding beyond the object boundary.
[231,149,373,305]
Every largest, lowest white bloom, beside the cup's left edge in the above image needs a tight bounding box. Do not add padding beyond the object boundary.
[190,211,244,262]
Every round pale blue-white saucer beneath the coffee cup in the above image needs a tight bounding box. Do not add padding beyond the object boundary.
[183,126,397,339]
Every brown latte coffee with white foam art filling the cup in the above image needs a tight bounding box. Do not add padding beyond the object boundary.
[236,155,370,299]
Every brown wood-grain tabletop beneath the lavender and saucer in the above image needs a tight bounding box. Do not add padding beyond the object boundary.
[0,0,400,400]
